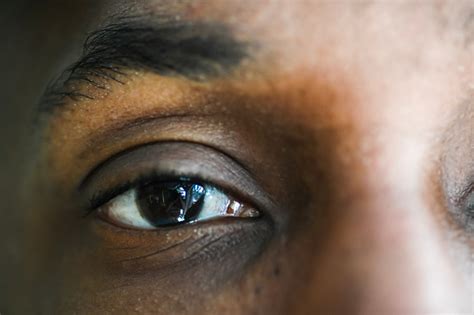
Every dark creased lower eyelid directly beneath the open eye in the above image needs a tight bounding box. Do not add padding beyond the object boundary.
[91,220,272,282]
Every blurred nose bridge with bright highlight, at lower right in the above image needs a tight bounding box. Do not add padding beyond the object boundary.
[292,140,469,314]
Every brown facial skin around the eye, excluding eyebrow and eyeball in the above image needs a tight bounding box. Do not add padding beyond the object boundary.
[7,0,474,314]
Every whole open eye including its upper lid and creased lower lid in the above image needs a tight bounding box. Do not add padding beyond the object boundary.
[79,141,275,276]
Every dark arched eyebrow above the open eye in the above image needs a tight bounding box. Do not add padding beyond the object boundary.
[39,15,249,112]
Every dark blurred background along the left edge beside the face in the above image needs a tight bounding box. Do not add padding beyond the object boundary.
[0,0,102,314]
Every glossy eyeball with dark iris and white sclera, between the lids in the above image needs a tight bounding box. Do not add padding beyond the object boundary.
[98,181,260,229]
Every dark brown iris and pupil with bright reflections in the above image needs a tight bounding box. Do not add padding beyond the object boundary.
[137,182,206,227]
